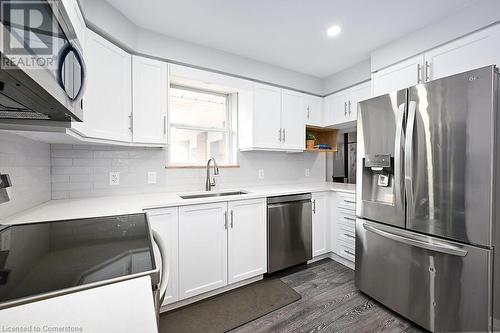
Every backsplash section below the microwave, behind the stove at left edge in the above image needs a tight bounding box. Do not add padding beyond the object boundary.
[0,132,51,220]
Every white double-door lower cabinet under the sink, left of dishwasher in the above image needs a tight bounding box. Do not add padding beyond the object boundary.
[179,199,267,300]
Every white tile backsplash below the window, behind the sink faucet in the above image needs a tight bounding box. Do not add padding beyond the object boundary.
[51,145,325,199]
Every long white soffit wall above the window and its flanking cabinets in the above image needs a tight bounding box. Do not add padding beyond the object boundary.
[80,0,323,95]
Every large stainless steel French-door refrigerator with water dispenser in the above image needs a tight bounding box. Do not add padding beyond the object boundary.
[355,66,500,332]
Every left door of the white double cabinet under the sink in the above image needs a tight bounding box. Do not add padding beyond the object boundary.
[179,202,227,299]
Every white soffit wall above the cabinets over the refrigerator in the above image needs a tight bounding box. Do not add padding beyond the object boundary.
[371,0,500,72]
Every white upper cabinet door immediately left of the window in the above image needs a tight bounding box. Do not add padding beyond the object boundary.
[132,56,168,144]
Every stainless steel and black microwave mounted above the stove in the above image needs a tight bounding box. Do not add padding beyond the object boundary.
[0,0,86,125]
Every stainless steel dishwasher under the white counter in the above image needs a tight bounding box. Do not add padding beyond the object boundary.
[267,193,312,273]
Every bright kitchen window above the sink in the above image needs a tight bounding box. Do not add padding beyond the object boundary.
[168,85,236,167]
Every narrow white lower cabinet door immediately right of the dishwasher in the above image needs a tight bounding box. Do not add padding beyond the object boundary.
[312,193,329,257]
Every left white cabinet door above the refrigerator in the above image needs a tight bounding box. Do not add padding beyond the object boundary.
[372,55,424,96]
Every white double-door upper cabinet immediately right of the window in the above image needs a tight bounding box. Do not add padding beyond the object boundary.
[238,83,305,151]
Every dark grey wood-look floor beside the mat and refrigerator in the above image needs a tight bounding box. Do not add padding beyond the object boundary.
[231,259,425,333]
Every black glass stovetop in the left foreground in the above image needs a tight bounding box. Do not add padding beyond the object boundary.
[0,214,156,306]
